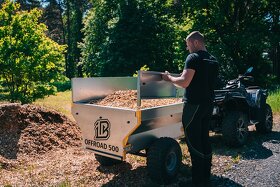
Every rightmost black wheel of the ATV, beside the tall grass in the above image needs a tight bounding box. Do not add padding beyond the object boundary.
[256,104,273,133]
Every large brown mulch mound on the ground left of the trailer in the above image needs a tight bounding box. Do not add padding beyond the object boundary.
[0,104,81,163]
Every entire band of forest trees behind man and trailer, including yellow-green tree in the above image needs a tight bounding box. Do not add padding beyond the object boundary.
[0,0,280,103]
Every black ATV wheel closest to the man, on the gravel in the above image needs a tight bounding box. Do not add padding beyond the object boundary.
[222,111,248,147]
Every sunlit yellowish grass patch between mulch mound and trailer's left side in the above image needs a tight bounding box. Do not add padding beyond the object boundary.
[33,91,73,119]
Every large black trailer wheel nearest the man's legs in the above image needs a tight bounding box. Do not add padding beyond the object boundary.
[147,137,182,184]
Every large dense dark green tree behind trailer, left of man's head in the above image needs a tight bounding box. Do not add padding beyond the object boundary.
[81,0,190,76]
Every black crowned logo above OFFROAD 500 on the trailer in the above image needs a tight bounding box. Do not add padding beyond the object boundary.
[94,118,111,140]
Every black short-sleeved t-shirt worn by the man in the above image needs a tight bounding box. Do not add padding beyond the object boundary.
[183,51,218,104]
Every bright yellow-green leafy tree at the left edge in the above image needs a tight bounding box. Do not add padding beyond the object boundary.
[0,0,65,103]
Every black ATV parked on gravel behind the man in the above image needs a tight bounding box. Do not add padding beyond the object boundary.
[210,67,273,147]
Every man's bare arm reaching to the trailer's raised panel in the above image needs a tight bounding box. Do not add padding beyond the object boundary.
[162,69,195,88]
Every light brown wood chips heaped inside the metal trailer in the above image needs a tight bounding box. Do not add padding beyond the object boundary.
[90,90,182,109]
